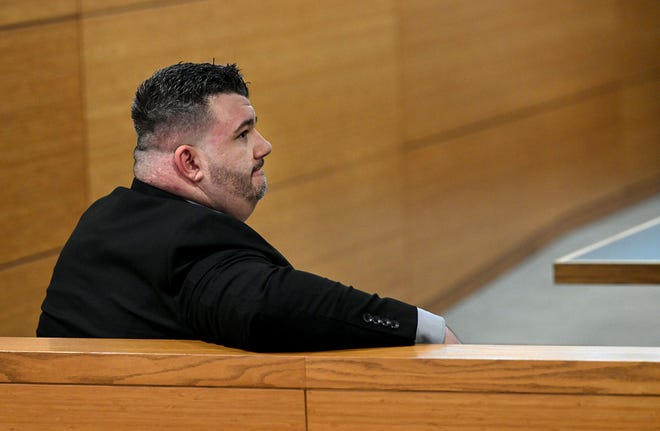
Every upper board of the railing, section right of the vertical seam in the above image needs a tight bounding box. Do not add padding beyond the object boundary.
[307,345,660,395]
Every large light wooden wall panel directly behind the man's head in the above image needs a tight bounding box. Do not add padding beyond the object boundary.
[83,0,398,197]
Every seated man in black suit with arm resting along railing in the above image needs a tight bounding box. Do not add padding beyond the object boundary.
[37,63,458,351]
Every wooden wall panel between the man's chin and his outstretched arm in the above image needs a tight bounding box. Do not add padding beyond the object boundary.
[249,155,408,296]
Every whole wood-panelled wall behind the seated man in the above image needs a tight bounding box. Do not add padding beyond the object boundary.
[0,0,660,336]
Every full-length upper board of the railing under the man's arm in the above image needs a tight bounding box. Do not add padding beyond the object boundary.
[0,338,660,395]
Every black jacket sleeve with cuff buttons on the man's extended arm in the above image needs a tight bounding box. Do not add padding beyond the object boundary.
[178,250,418,352]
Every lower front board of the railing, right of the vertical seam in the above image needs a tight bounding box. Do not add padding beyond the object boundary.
[307,390,660,431]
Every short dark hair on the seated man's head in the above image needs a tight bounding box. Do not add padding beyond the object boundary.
[131,63,249,151]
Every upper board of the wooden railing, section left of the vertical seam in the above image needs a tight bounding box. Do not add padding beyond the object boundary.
[0,338,304,388]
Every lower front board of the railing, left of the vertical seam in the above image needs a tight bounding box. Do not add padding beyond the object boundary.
[0,384,305,431]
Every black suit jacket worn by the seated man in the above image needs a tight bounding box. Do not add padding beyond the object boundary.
[37,180,417,351]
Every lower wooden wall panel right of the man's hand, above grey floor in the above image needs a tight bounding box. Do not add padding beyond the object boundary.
[404,90,626,306]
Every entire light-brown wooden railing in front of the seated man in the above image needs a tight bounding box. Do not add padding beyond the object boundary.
[0,338,660,431]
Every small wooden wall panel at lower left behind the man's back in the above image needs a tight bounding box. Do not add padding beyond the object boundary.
[0,256,56,337]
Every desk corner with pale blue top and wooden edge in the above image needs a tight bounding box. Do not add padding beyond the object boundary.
[554,217,660,284]
